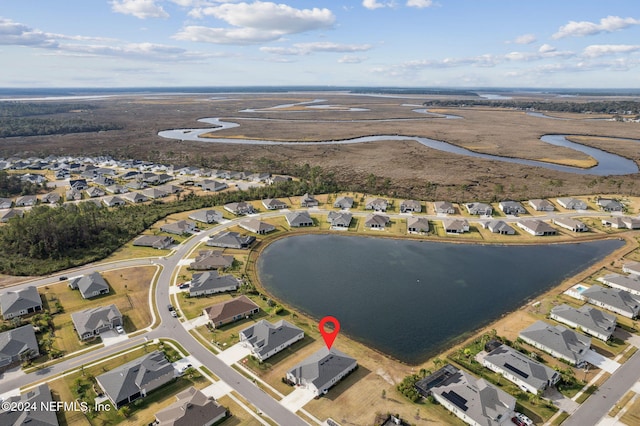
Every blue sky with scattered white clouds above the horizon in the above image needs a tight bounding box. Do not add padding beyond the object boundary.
[0,0,640,88]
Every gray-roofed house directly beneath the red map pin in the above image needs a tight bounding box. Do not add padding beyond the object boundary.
[286,348,358,396]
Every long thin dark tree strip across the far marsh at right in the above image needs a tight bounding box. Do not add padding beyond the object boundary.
[423,99,640,114]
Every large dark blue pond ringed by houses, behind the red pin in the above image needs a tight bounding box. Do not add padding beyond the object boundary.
[258,235,623,364]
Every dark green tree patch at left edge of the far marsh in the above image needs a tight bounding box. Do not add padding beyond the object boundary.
[0,117,123,138]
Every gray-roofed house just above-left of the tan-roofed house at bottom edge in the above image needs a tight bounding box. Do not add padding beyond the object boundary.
[96,351,175,408]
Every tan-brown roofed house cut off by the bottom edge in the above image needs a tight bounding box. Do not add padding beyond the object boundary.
[153,386,228,426]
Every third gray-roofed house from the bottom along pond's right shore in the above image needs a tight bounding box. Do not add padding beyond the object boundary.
[519,321,591,367]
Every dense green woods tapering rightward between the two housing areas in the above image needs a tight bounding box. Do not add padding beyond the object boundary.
[0,173,338,275]
